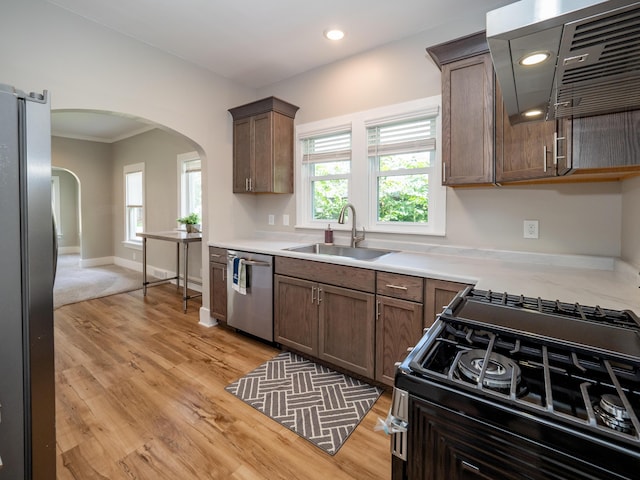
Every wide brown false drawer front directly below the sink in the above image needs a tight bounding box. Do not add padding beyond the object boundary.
[275,257,376,293]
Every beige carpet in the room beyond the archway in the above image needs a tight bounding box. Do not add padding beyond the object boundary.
[53,254,142,308]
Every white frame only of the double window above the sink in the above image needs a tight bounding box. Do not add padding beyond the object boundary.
[295,95,446,236]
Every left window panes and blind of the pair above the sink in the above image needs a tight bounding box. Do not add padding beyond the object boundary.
[302,132,351,224]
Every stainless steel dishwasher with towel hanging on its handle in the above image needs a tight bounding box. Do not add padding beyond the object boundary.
[227,250,273,342]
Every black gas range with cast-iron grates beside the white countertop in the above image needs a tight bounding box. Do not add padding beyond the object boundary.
[391,288,640,480]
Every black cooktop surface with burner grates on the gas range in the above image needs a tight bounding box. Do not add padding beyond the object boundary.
[411,318,640,445]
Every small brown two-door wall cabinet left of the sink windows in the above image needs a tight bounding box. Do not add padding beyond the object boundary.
[229,97,298,193]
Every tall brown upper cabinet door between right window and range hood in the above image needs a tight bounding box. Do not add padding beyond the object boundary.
[442,53,494,185]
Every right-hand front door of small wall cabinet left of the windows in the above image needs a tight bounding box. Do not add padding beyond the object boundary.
[251,112,273,193]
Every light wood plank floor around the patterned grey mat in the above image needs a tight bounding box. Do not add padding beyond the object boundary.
[55,285,391,480]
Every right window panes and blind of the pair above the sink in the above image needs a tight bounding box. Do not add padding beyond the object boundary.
[367,118,435,225]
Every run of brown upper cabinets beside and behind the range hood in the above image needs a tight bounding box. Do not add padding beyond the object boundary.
[427,32,640,186]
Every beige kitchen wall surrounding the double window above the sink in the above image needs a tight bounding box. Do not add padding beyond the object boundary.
[254,18,622,256]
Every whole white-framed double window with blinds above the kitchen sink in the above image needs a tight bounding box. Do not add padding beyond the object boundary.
[296,96,446,235]
